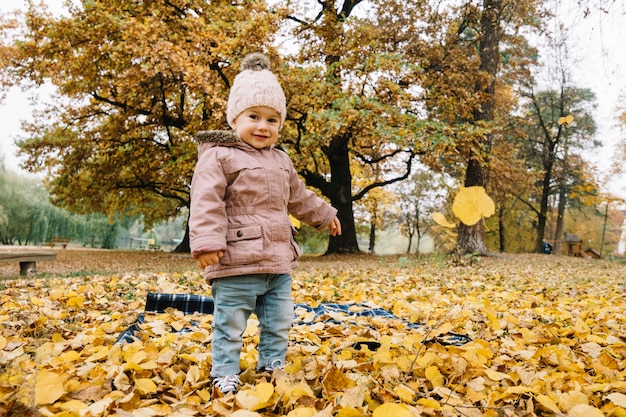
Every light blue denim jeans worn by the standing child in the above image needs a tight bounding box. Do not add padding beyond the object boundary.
[211,274,294,377]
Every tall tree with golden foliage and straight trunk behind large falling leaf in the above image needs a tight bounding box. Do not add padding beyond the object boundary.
[402,1,545,253]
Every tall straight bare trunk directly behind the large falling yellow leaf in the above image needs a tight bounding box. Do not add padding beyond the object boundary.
[450,0,503,253]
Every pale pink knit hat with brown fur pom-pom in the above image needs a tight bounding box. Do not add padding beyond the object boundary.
[226,52,287,127]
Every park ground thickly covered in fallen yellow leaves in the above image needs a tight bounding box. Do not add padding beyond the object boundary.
[0,249,626,417]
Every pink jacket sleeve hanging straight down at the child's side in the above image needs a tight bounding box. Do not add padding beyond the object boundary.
[189,144,228,258]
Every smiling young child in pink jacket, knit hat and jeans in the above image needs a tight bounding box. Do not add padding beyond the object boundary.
[189,53,341,394]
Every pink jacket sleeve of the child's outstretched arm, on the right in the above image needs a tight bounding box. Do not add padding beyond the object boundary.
[287,157,337,230]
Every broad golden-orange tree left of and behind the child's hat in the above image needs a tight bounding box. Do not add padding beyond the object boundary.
[0,0,279,250]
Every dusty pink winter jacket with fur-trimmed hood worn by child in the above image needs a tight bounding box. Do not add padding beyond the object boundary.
[189,131,337,280]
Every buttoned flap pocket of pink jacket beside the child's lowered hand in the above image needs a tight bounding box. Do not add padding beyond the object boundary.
[220,224,263,265]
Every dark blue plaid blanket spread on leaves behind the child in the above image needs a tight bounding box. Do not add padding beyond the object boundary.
[115,292,471,346]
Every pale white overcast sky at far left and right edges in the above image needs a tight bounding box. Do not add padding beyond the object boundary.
[0,0,626,198]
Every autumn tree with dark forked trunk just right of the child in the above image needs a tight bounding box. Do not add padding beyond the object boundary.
[282,0,436,253]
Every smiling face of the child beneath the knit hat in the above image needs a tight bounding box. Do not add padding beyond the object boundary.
[233,107,280,149]
